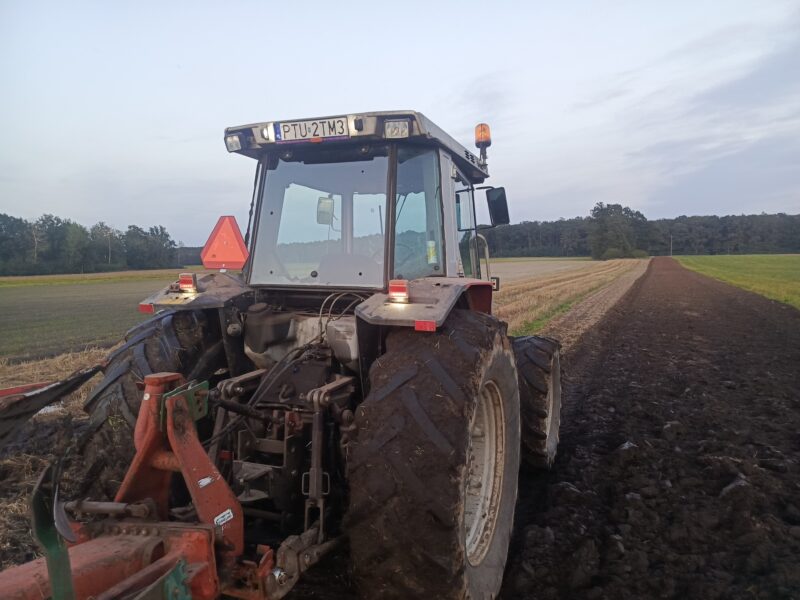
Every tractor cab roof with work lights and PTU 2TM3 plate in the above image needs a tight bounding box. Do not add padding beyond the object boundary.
[225,110,489,183]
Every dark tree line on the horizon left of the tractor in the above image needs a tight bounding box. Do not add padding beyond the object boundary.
[0,214,199,275]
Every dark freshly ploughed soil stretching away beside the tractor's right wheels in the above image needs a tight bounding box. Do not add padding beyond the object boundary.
[0,258,800,600]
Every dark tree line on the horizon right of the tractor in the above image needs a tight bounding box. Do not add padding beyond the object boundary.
[482,203,800,259]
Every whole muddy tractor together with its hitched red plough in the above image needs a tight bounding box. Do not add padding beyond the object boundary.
[0,111,561,600]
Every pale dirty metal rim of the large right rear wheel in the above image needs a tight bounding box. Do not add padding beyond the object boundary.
[464,381,505,566]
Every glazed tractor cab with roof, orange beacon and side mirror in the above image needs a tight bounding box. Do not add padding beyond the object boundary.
[225,111,508,291]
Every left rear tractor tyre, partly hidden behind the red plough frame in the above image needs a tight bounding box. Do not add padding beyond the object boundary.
[68,311,224,500]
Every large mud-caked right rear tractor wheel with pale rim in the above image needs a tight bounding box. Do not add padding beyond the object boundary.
[345,310,520,600]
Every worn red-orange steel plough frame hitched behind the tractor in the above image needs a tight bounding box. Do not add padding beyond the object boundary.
[0,373,284,600]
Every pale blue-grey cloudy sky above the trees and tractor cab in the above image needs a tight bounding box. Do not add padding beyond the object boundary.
[0,0,800,245]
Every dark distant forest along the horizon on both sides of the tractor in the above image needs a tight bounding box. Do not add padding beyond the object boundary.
[0,209,800,275]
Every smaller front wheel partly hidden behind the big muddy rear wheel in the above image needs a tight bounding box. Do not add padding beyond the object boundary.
[513,335,561,469]
